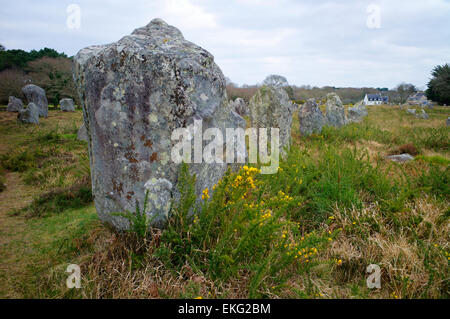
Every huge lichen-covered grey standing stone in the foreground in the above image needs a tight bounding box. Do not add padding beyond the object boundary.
[74,19,245,229]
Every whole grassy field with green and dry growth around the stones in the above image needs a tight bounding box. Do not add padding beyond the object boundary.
[0,106,450,299]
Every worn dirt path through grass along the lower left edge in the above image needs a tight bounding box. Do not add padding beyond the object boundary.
[0,173,36,298]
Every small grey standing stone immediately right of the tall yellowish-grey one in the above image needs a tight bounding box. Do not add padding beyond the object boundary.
[298,99,327,136]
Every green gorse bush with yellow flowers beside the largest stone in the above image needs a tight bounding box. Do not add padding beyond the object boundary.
[155,166,330,297]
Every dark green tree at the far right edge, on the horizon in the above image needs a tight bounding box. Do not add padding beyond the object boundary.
[426,63,450,105]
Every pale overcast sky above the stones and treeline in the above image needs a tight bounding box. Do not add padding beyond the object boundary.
[0,0,450,88]
